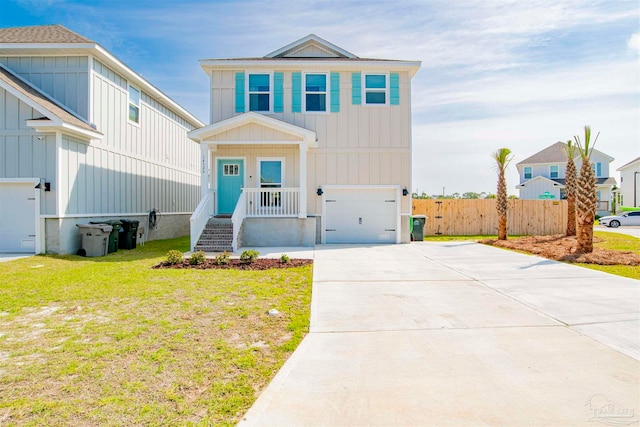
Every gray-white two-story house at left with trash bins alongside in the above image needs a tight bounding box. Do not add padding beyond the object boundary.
[0,25,203,253]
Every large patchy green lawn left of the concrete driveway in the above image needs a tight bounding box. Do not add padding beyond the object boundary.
[0,238,312,426]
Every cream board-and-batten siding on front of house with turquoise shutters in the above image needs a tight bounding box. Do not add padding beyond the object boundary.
[211,66,411,221]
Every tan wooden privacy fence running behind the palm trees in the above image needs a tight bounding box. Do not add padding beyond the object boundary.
[413,199,567,236]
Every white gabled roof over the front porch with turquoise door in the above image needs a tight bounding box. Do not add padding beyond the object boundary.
[188,112,317,147]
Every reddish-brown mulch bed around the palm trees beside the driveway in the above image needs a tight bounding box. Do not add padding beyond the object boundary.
[479,234,640,265]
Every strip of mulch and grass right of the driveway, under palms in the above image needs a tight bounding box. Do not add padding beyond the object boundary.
[480,232,640,279]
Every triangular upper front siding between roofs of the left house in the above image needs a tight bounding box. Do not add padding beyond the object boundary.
[0,56,89,119]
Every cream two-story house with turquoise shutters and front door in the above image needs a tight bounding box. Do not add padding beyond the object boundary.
[189,34,420,250]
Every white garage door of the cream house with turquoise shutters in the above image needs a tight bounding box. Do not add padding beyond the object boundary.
[324,188,398,243]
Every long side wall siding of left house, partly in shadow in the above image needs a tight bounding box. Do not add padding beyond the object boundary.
[90,60,200,214]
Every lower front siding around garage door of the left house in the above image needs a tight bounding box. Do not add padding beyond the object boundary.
[0,89,57,214]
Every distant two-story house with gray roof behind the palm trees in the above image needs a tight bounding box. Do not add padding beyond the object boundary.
[516,142,616,215]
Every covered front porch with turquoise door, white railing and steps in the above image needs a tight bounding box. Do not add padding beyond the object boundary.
[189,112,316,251]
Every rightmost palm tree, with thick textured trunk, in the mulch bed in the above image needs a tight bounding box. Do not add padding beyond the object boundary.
[573,126,600,253]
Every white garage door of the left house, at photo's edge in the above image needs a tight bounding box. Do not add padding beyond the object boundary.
[0,183,37,252]
